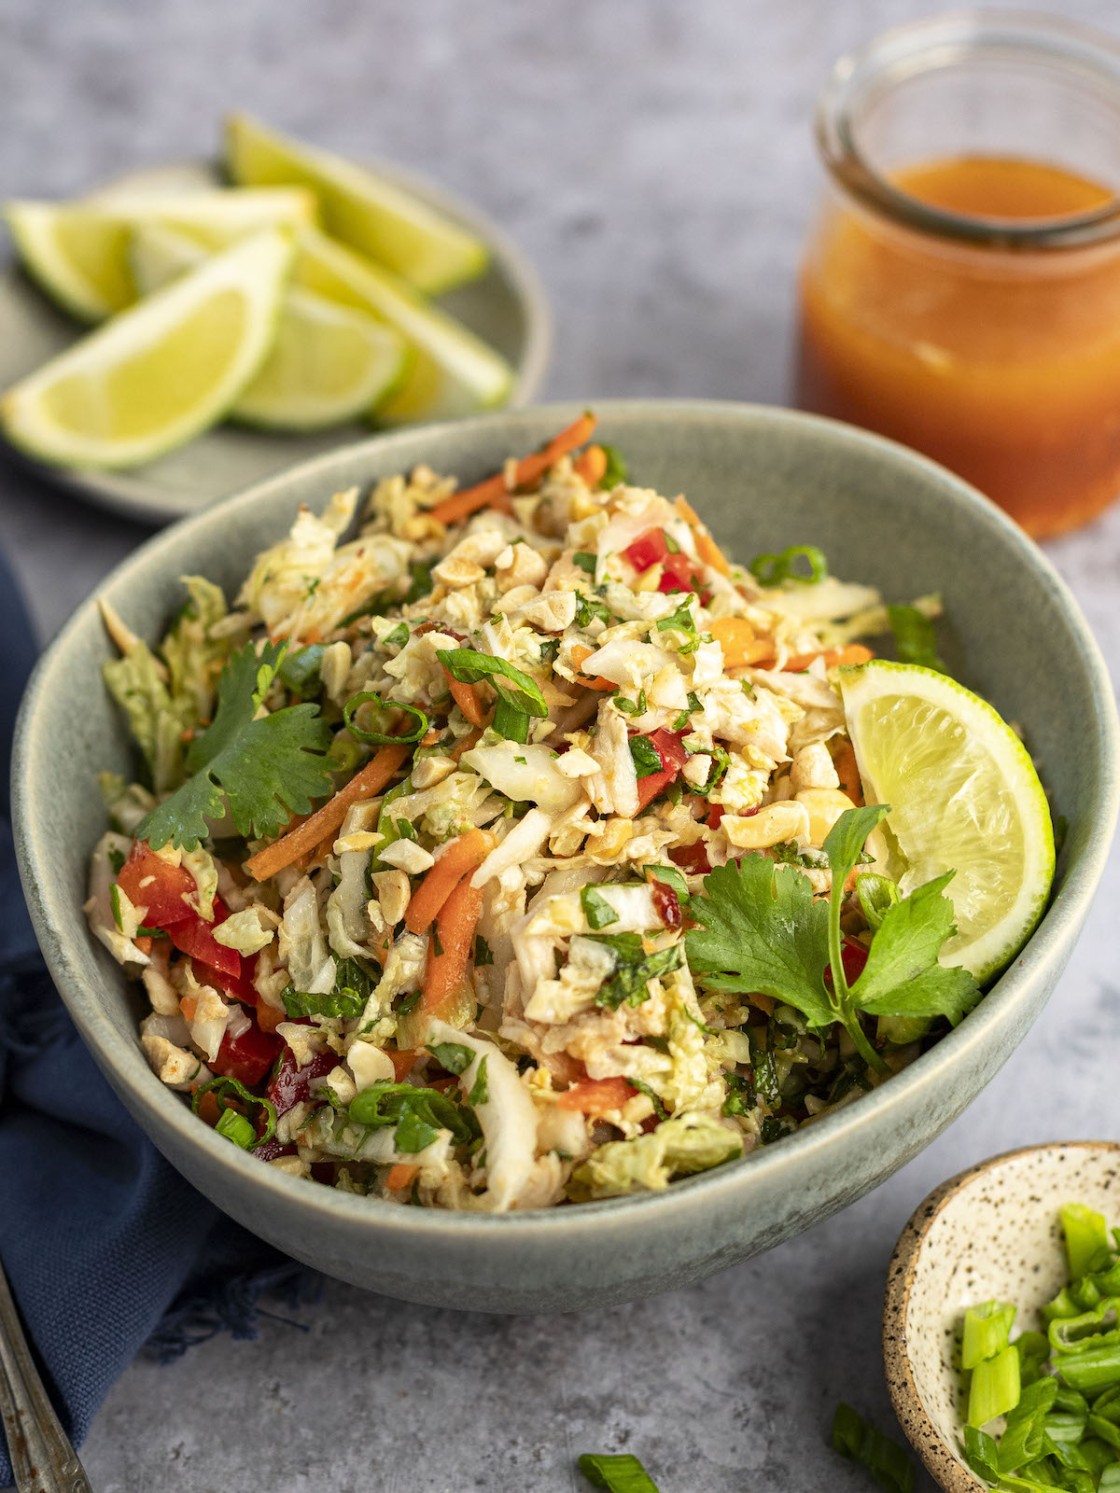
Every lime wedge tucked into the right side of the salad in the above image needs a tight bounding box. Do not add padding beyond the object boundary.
[839,660,1054,981]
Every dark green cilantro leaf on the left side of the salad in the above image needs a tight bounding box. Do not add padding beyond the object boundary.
[136,643,332,850]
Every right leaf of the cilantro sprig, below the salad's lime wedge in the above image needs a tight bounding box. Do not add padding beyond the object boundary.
[851,870,980,1026]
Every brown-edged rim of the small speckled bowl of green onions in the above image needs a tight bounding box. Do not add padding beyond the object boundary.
[883,1141,1120,1493]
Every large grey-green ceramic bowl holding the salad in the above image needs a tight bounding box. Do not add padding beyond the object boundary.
[13,402,1119,1312]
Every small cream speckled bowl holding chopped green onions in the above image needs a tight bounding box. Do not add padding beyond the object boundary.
[883,1141,1120,1493]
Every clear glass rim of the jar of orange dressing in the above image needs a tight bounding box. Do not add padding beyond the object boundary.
[815,9,1120,251]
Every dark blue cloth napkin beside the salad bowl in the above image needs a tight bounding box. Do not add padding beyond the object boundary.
[0,555,315,1489]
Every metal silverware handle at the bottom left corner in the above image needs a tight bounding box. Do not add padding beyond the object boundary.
[0,1266,93,1493]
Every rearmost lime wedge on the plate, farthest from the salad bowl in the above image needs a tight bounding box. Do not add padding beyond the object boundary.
[225,113,487,296]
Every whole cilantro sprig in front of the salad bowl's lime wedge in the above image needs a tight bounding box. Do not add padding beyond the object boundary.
[685,803,980,1072]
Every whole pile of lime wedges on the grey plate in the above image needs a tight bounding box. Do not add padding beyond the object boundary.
[0,116,512,467]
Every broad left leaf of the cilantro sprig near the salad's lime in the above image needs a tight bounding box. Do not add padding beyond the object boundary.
[684,854,838,1026]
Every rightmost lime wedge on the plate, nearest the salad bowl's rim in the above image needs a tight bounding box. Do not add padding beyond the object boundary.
[293,228,514,424]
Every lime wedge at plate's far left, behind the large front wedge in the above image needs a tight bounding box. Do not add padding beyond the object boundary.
[4,188,315,321]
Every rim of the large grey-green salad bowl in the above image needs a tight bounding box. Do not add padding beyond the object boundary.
[12,399,1120,1245]
